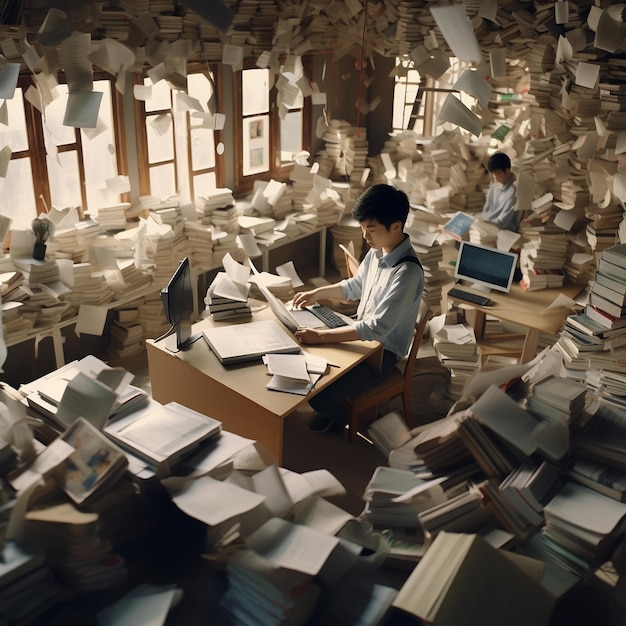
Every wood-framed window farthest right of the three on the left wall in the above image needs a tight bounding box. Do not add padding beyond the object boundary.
[235,56,311,192]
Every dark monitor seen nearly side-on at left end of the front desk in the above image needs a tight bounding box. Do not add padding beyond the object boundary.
[161,257,199,350]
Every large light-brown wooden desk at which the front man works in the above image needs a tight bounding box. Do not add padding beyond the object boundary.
[146,308,382,464]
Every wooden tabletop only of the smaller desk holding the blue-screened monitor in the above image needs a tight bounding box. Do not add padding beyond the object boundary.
[447,283,583,335]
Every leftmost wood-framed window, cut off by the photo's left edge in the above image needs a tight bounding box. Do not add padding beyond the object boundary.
[0,77,125,229]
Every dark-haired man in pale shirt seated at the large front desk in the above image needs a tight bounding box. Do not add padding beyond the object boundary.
[293,184,424,433]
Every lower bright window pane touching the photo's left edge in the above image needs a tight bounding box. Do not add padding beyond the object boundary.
[0,158,36,230]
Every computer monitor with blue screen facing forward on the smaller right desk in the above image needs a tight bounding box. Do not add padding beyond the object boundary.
[454,241,517,293]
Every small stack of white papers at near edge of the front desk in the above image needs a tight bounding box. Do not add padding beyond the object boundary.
[263,354,328,396]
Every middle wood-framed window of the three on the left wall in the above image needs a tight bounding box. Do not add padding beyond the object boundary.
[137,64,223,202]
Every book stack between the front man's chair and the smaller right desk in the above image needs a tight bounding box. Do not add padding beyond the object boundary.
[433,324,481,400]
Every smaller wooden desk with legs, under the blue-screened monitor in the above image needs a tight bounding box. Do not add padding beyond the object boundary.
[443,283,583,363]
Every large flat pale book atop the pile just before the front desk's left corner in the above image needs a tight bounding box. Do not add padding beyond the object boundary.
[104,400,222,468]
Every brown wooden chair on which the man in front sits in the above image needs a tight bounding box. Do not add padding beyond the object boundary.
[343,309,433,442]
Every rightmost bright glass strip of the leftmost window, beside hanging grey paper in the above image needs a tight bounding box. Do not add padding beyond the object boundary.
[81,80,119,211]
